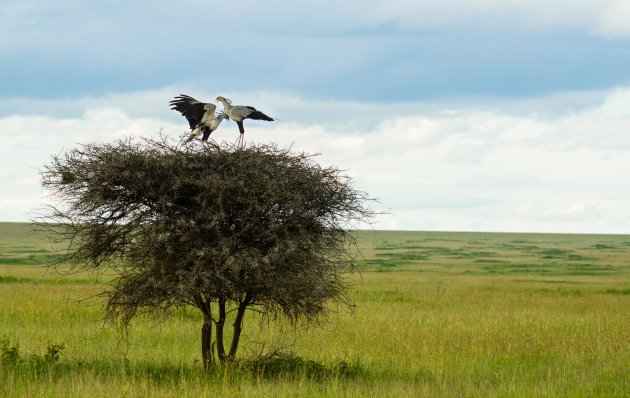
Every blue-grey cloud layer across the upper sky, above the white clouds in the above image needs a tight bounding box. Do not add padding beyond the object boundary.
[0,0,630,103]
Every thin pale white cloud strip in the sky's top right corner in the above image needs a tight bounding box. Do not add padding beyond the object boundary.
[367,0,630,37]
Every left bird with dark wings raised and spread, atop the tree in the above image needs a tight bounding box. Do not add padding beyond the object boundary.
[169,94,228,143]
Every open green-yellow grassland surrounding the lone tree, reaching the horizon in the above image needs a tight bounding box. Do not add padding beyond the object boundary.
[0,223,630,397]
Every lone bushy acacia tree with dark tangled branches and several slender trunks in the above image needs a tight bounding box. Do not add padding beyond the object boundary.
[41,139,373,367]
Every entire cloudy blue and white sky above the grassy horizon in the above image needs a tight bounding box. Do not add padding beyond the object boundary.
[0,0,630,234]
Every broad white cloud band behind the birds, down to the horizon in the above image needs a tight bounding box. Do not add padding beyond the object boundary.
[0,88,630,232]
